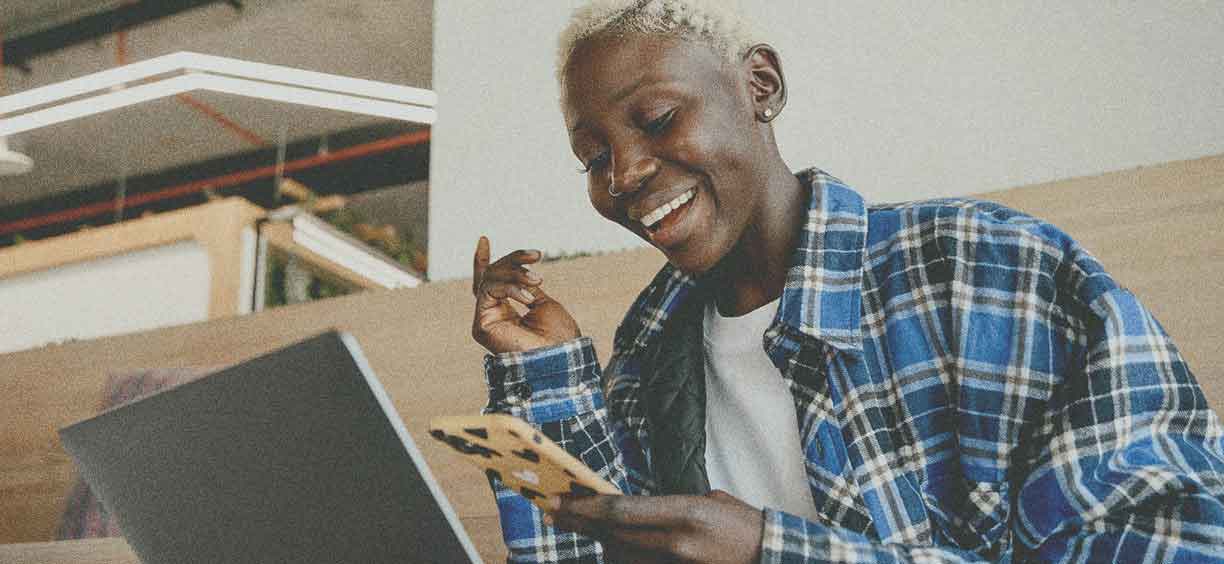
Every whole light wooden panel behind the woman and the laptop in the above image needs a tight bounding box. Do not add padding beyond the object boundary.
[0,155,1224,562]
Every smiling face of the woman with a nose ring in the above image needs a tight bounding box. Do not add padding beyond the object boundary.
[563,34,765,273]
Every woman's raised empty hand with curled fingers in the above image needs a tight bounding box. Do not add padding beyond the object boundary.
[471,237,581,354]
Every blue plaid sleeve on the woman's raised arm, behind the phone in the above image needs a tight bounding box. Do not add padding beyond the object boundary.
[483,338,641,563]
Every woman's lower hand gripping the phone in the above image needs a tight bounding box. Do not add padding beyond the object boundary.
[551,489,765,564]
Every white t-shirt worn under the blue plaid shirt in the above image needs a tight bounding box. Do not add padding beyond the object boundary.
[704,300,816,520]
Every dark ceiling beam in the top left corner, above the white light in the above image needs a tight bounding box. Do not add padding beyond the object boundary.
[4,0,242,72]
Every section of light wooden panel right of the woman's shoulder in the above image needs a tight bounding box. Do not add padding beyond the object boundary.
[982,155,1224,403]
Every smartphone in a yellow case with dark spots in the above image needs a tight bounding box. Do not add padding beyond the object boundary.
[430,415,621,509]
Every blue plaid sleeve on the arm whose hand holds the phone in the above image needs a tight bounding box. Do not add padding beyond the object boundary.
[761,222,1224,563]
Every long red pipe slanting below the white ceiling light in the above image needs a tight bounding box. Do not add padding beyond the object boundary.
[0,130,430,235]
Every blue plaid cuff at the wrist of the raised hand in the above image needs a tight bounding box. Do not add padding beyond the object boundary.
[485,336,603,423]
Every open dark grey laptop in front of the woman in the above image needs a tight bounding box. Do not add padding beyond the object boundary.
[60,332,480,564]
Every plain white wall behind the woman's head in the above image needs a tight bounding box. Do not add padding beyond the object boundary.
[430,0,1224,280]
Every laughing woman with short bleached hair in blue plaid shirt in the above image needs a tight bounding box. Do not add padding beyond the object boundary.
[472,0,1224,563]
